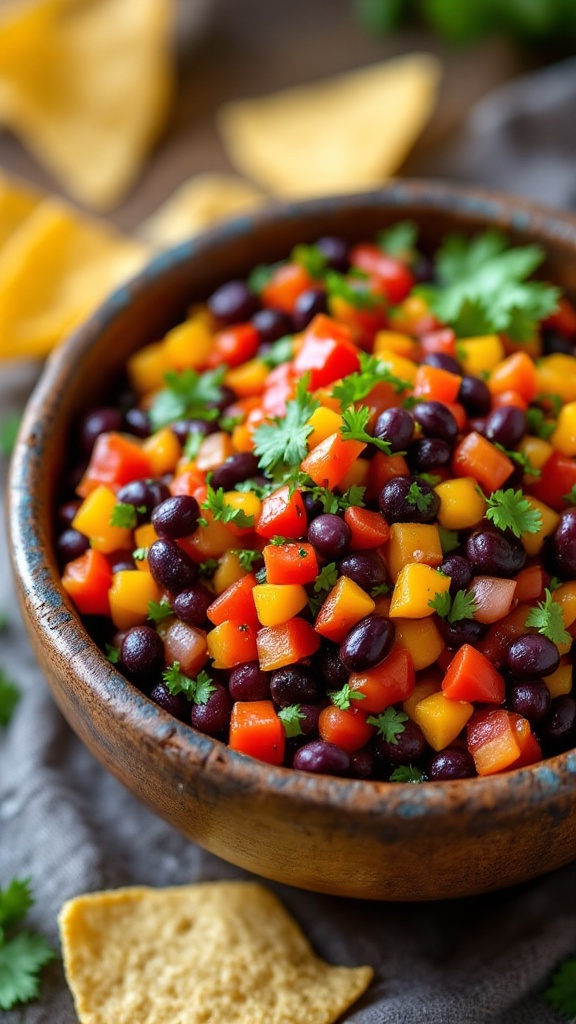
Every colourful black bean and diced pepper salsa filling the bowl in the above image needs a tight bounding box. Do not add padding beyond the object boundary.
[57,221,576,782]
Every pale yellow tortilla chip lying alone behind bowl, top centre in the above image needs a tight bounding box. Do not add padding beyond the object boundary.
[218,53,440,197]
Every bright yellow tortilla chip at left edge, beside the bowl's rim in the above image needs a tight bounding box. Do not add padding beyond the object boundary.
[0,199,148,358]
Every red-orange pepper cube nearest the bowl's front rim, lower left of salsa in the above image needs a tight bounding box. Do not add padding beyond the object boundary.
[229,700,286,765]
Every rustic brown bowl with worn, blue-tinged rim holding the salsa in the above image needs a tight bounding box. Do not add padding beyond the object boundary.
[8,182,576,900]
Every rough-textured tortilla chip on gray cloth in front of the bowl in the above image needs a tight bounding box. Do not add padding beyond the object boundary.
[59,882,372,1024]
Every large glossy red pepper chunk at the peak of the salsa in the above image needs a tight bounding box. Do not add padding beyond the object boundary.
[292,313,360,391]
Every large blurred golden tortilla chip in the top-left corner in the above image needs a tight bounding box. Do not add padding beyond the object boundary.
[0,0,172,207]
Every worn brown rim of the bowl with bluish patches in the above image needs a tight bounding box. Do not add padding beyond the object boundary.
[7,179,576,818]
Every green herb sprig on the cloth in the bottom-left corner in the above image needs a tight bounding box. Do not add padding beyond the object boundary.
[0,879,55,1010]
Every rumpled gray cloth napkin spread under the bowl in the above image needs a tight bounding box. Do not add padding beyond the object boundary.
[0,62,576,1024]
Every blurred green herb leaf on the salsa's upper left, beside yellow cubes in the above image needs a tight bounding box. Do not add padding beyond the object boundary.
[149,366,228,430]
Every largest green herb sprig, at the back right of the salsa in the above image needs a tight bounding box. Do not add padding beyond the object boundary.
[420,230,560,341]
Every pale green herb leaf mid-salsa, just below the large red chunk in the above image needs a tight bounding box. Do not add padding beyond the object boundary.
[252,374,320,475]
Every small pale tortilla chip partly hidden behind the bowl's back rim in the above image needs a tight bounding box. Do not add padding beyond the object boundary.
[139,173,265,248]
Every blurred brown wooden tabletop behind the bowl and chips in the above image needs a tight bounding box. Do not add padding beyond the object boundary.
[0,0,537,230]
